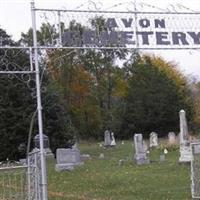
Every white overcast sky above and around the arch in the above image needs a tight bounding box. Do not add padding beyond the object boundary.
[0,0,200,79]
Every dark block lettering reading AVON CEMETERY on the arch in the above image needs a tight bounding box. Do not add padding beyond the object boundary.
[63,18,200,47]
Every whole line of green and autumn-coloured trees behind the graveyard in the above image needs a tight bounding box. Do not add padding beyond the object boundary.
[0,19,200,160]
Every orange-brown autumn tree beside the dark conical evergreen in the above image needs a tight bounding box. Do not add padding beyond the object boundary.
[47,51,100,138]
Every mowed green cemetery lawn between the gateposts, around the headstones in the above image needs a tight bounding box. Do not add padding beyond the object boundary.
[48,141,192,200]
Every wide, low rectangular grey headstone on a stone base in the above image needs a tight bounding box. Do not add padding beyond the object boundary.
[55,148,83,171]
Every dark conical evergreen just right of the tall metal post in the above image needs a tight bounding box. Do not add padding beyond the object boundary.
[41,80,77,154]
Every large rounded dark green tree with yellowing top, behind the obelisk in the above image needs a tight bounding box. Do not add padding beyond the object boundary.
[122,55,192,137]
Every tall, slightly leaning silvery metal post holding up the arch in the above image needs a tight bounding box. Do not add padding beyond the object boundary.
[31,0,48,200]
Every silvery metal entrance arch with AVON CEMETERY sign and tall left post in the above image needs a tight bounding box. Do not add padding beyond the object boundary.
[0,1,200,200]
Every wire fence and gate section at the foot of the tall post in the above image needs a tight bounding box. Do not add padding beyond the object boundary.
[0,151,41,200]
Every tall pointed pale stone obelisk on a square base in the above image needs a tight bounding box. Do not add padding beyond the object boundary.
[179,110,192,163]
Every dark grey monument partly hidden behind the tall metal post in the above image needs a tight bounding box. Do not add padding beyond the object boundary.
[34,134,54,158]
